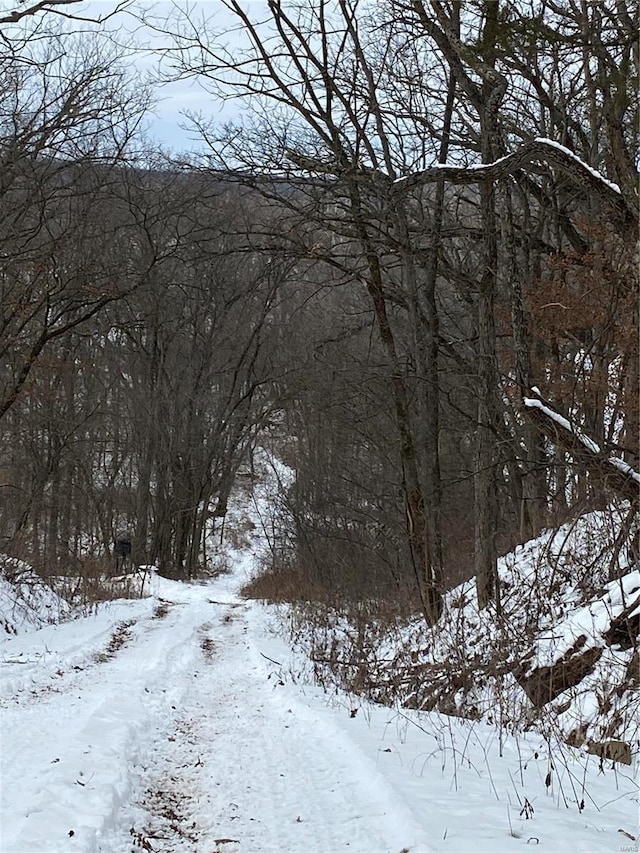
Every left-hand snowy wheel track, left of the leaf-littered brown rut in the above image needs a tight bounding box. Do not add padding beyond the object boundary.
[0,596,216,853]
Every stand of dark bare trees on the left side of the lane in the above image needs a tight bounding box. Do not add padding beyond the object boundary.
[0,11,290,576]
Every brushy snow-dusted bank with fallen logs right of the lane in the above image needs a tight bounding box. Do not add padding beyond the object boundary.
[289,506,640,752]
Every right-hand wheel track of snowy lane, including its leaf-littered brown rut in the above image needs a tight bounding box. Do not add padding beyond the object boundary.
[98,603,430,853]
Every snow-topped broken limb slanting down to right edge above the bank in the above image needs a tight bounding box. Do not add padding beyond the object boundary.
[523,388,640,503]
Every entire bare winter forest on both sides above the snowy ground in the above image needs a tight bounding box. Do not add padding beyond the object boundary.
[0,0,640,625]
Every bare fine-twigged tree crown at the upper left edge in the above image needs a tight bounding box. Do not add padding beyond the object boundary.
[0,27,148,418]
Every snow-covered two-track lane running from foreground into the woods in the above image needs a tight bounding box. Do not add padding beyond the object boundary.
[1,581,428,853]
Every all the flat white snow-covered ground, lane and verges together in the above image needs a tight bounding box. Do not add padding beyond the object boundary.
[0,466,639,853]
